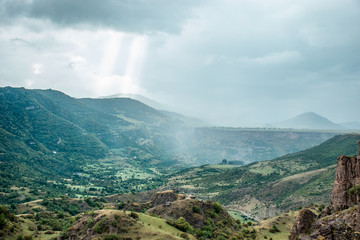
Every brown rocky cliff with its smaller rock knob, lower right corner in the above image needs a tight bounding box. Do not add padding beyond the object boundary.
[289,141,360,240]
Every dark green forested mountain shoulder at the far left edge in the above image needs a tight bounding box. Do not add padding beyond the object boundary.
[0,88,108,185]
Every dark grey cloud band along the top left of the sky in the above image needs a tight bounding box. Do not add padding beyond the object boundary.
[0,0,200,33]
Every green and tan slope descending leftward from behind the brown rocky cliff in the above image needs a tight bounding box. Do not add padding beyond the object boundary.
[166,134,360,218]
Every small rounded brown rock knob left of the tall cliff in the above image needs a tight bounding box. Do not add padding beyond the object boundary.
[289,208,316,240]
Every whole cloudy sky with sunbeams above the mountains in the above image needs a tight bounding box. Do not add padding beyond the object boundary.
[0,0,360,127]
